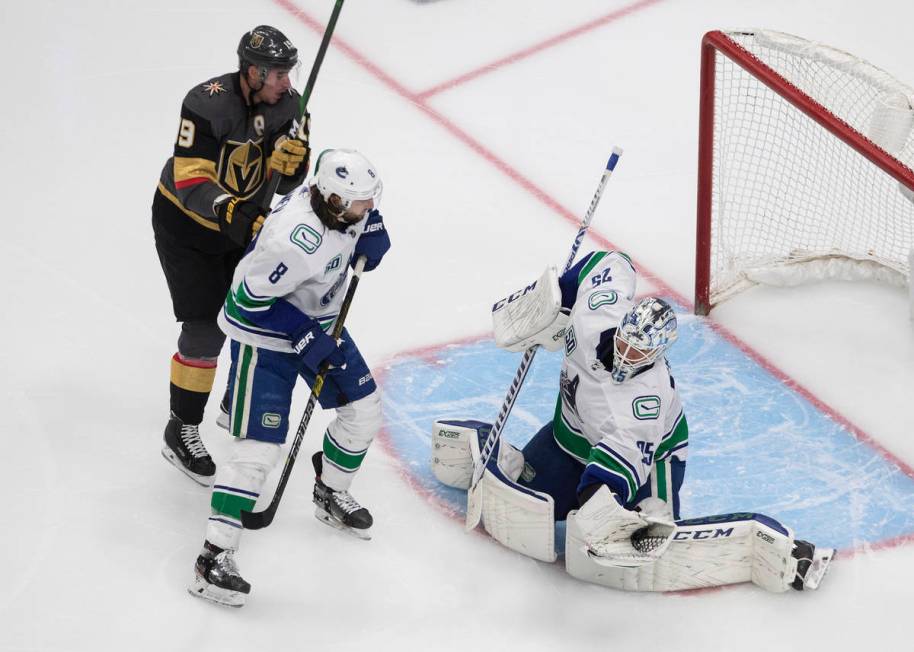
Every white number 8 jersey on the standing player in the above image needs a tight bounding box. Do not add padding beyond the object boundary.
[218,185,366,353]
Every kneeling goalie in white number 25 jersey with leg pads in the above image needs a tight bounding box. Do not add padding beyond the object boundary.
[432,252,834,592]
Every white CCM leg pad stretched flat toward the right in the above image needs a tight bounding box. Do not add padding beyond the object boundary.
[565,512,800,592]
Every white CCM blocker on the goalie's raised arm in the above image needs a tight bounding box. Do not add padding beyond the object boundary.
[492,267,571,351]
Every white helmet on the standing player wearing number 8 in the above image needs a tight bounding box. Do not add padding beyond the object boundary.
[314,149,383,211]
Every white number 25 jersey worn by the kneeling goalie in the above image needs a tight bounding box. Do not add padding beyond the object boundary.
[553,252,688,504]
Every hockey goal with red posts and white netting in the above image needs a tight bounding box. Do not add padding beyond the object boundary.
[695,30,914,314]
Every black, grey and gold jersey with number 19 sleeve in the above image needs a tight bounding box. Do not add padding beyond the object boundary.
[154,72,301,247]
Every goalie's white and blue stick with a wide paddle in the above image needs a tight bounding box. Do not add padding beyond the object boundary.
[466,147,622,532]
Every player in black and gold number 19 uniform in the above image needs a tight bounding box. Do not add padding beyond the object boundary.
[152,25,310,485]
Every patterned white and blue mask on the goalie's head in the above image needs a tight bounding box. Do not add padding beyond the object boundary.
[610,297,677,383]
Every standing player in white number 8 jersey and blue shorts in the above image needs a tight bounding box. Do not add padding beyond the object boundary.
[188,149,390,606]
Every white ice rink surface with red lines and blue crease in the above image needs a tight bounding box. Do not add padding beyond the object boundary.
[0,0,914,652]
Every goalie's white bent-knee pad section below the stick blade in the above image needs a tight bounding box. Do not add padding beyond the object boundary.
[478,460,556,562]
